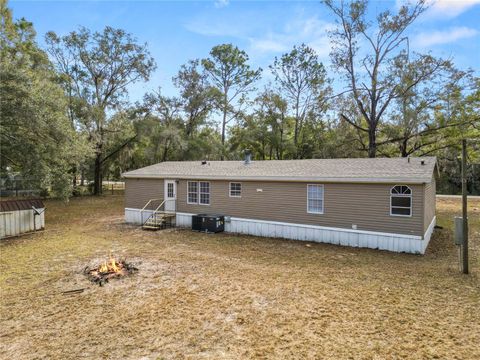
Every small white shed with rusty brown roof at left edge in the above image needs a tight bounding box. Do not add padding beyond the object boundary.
[0,199,45,239]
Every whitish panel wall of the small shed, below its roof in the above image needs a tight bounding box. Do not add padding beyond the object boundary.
[0,209,45,239]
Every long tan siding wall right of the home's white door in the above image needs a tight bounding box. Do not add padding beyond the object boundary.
[178,180,425,236]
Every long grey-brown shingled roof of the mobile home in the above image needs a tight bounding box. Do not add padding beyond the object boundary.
[123,157,436,184]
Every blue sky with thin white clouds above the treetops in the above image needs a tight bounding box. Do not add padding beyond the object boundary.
[10,0,480,101]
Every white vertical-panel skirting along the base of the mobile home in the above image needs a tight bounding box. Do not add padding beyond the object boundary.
[125,209,436,254]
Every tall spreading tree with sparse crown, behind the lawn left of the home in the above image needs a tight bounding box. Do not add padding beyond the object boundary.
[46,26,155,195]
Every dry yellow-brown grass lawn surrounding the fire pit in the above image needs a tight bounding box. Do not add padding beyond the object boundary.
[0,196,480,359]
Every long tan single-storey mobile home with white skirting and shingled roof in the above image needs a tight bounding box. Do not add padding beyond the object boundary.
[124,155,436,254]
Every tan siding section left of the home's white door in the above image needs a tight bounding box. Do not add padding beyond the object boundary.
[125,179,164,209]
